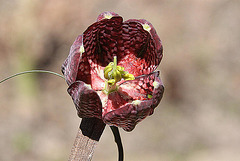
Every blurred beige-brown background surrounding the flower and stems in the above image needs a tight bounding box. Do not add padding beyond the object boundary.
[0,0,240,161]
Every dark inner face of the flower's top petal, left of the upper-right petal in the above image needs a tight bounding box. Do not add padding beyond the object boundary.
[83,17,122,67]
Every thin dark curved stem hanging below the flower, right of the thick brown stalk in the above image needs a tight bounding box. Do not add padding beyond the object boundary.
[110,126,124,161]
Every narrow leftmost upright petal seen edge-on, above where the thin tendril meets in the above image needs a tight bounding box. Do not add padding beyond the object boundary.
[62,35,91,85]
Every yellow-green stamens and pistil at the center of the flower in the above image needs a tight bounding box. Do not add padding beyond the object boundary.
[103,56,135,94]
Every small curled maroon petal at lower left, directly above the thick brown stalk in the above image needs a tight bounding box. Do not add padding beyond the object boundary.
[68,81,102,119]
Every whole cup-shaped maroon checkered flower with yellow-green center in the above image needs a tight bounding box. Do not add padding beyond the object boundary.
[62,12,164,131]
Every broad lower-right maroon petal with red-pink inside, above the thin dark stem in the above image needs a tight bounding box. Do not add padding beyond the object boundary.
[103,73,164,131]
